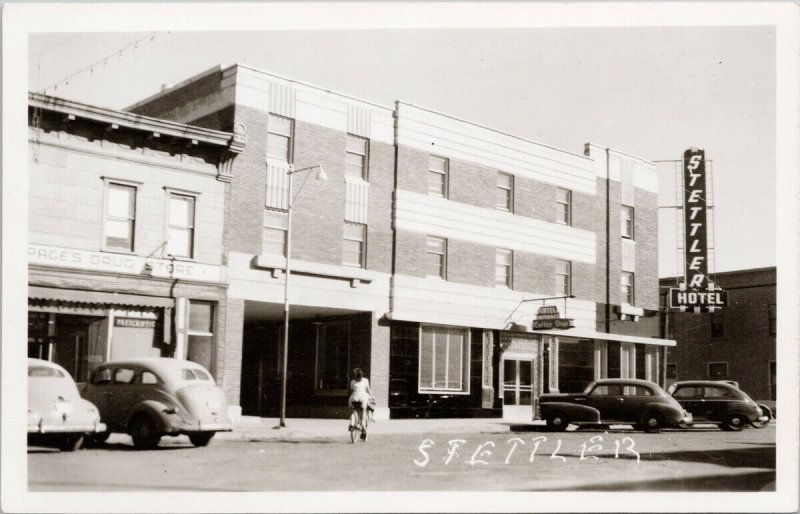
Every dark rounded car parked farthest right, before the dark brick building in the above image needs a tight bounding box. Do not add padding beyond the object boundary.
[668,380,769,431]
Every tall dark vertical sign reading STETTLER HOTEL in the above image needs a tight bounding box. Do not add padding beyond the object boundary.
[670,148,727,312]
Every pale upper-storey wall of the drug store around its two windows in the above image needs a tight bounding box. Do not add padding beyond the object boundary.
[28,124,224,264]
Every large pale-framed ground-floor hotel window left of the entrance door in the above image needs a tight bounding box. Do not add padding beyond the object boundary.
[419,326,469,392]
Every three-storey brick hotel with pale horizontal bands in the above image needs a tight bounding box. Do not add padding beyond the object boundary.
[29,65,675,420]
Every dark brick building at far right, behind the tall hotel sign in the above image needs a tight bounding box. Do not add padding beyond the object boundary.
[661,267,777,405]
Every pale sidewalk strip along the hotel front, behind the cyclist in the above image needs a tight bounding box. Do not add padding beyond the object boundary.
[216,416,544,441]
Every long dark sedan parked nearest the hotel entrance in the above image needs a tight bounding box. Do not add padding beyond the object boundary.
[539,378,691,432]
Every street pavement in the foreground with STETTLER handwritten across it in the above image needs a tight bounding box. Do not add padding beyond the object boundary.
[28,418,775,491]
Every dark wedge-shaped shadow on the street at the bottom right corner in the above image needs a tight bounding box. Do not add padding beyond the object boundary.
[536,471,775,492]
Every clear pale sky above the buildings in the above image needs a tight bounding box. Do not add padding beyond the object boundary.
[28,26,776,276]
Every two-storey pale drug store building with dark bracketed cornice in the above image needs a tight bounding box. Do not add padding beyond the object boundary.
[28,93,241,388]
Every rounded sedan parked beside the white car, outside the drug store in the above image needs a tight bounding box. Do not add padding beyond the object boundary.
[82,357,233,449]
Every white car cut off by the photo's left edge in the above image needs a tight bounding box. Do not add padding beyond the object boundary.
[28,359,106,451]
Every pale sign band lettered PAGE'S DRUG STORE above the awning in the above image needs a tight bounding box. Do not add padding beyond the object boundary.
[28,244,222,282]
